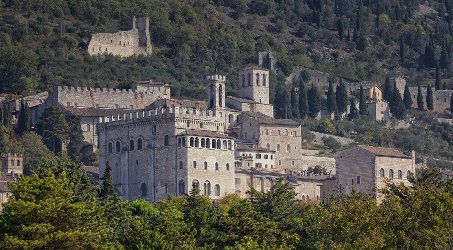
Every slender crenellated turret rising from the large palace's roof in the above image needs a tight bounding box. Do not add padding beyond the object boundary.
[206,75,226,114]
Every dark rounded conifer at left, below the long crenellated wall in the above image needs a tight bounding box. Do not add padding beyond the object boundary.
[37,105,70,153]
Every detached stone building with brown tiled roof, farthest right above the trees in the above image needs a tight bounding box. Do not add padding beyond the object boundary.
[336,145,415,201]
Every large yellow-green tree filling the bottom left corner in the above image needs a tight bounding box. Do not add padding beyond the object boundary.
[0,171,110,249]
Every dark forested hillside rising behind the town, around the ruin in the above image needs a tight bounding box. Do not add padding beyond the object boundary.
[0,0,453,98]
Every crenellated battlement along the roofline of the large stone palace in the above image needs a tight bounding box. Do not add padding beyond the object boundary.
[99,107,223,126]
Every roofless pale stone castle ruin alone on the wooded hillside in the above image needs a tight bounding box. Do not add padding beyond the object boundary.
[88,16,152,57]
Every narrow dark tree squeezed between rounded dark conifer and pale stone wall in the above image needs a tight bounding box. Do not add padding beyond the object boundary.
[65,112,83,161]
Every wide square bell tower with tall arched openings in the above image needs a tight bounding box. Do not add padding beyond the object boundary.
[239,67,269,104]
